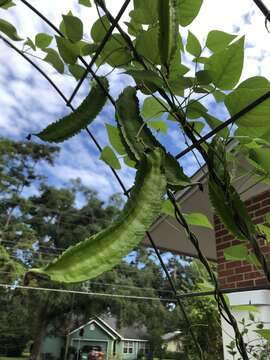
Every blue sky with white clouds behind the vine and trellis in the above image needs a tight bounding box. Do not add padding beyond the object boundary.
[0,0,270,199]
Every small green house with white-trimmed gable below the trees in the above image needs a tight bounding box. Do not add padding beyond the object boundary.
[42,317,149,360]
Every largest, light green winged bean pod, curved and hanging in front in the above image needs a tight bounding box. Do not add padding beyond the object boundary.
[26,149,166,283]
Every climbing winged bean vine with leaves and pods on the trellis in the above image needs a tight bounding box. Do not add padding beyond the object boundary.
[0,0,270,359]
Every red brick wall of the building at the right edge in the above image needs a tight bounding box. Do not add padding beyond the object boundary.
[214,190,270,289]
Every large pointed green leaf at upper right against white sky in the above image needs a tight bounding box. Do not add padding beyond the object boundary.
[205,36,244,90]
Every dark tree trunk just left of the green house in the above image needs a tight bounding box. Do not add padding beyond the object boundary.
[30,305,48,360]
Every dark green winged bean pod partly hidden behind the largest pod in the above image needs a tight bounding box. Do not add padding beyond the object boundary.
[116,86,189,189]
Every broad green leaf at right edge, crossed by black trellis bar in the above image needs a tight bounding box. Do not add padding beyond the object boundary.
[225,76,270,139]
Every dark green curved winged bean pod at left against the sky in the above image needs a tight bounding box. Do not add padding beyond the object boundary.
[35,78,109,143]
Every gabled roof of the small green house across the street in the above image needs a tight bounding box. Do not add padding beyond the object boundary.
[69,316,148,340]
